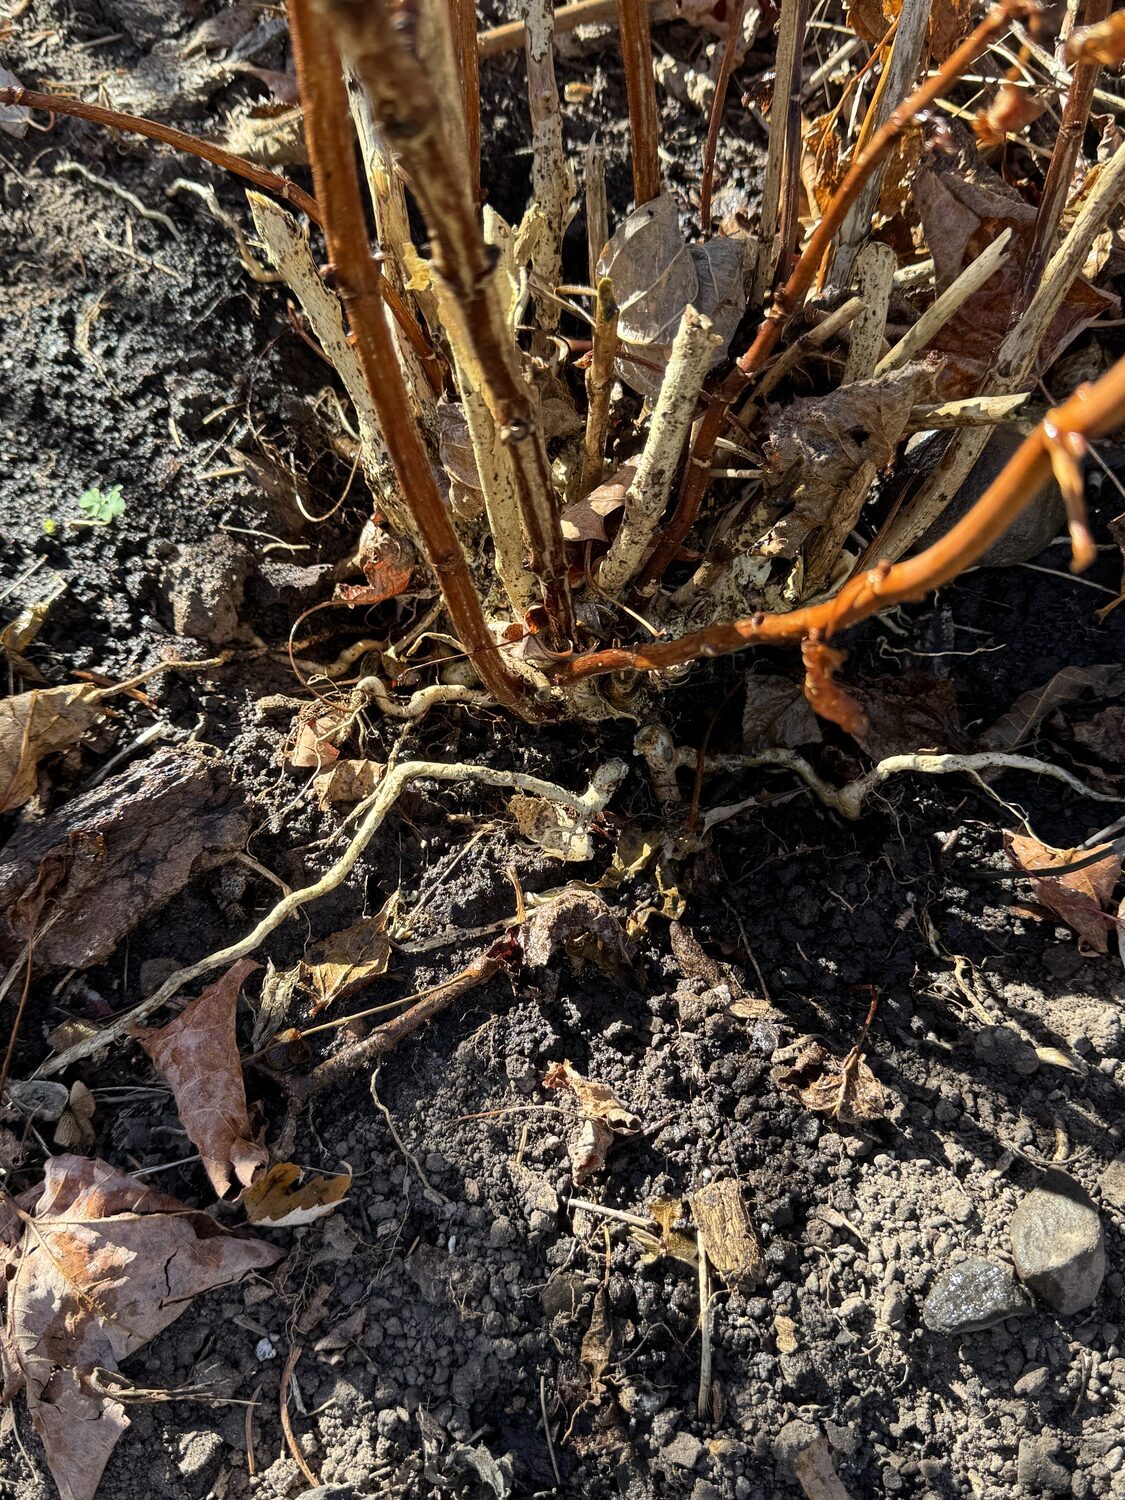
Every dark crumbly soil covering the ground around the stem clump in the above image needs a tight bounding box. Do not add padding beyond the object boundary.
[0,0,1125,1500]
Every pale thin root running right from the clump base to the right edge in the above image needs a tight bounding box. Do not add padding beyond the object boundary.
[657,746,1122,831]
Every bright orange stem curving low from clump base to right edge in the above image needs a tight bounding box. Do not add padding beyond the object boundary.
[554,348,1125,686]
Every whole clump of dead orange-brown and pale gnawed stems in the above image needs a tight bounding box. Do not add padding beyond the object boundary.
[0,0,1125,728]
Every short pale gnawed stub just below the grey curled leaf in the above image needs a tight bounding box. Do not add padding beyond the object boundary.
[597,308,723,596]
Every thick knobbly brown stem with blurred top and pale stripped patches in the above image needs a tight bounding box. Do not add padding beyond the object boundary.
[321,0,576,645]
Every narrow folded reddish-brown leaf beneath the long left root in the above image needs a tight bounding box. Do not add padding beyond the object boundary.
[131,959,270,1197]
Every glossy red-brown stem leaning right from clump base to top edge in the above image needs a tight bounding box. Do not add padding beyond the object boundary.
[638,0,1028,590]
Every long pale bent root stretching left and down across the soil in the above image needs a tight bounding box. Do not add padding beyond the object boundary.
[38,761,627,1079]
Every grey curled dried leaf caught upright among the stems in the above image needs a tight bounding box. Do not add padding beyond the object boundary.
[597,194,747,396]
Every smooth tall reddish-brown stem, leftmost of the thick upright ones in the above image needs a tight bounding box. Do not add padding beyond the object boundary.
[288,0,543,719]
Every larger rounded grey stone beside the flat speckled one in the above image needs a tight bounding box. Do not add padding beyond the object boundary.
[1011,1172,1106,1313]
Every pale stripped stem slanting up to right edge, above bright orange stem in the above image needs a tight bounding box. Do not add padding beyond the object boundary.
[882,133,1125,561]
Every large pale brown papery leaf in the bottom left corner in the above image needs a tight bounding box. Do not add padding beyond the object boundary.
[5,1157,281,1500]
